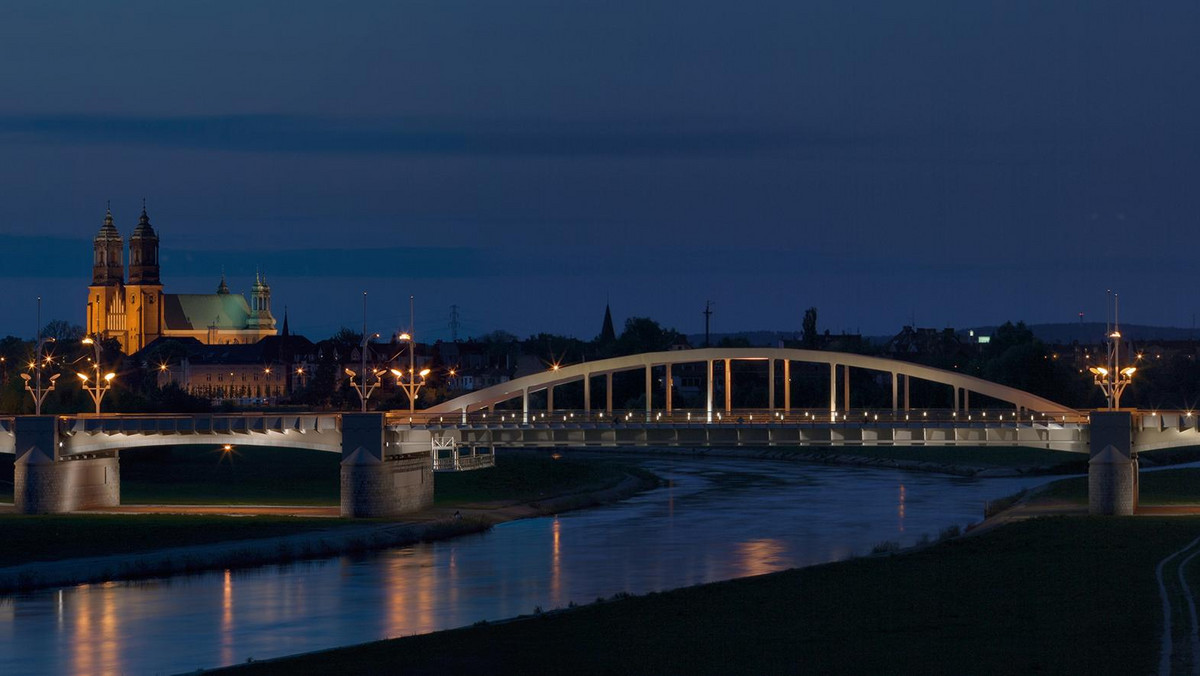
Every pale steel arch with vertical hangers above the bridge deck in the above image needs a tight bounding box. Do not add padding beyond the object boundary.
[422,347,1079,414]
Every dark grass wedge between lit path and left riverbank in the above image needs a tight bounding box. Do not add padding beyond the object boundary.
[0,514,362,567]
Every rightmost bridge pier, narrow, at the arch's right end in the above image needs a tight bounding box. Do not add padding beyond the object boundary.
[1087,411,1138,516]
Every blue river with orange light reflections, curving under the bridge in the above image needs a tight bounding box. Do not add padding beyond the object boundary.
[0,459,1043,676]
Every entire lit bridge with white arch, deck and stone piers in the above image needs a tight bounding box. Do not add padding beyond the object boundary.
[0,348,1200,516]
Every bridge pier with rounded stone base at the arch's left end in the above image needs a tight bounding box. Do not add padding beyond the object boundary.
[341,413,433,519]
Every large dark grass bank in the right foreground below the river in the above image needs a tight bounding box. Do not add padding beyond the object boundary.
[222,518,1200,676]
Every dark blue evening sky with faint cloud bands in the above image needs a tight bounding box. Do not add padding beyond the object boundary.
[0,0,1200,339]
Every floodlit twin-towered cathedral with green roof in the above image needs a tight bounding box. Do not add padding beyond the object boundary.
[86,204,276,354]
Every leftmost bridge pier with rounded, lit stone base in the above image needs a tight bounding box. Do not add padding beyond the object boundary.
[13,415,121,514]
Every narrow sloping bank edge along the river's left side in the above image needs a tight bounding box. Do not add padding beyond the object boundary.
[0,474,659,596]
